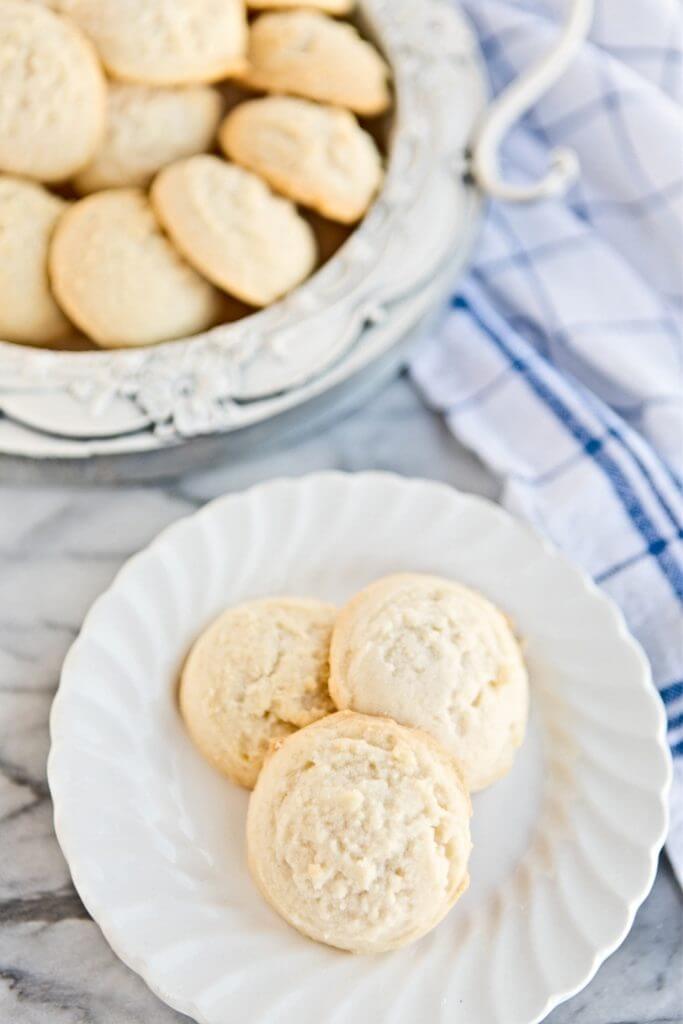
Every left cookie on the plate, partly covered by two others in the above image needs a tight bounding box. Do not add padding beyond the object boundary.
[179,597,337,788]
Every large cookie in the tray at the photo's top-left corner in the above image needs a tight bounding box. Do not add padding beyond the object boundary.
[0,0,105,181]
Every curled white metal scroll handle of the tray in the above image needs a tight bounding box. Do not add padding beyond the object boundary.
[470,0,594,203]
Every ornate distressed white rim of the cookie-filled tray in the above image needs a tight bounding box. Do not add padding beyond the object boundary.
[0,0,486,456]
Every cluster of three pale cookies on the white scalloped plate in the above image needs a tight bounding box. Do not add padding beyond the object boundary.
[179,573,528,953]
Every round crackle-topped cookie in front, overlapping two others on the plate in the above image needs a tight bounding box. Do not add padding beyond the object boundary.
[247,712,471,953]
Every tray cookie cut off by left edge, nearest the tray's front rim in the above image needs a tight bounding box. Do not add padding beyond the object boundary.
[0,174,72,345]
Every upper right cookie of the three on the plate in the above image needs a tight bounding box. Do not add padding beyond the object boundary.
[330,573,528,791]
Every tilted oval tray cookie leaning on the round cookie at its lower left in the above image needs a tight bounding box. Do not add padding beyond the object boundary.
[152,156,316,306]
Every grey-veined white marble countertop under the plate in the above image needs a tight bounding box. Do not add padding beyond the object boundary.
[0,379,683,1024]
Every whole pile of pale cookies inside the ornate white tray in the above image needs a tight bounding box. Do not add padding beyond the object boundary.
[0,0,391,348]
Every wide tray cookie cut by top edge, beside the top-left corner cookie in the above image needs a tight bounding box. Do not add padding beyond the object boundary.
[60,0,247,85]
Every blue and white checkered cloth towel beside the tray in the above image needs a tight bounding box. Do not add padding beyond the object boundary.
[412,0,683,884]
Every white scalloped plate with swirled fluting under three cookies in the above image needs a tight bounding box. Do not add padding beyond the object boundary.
[48,473,671,1024]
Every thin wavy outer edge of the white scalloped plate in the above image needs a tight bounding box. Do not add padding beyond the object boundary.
[47,470,673,1024]
